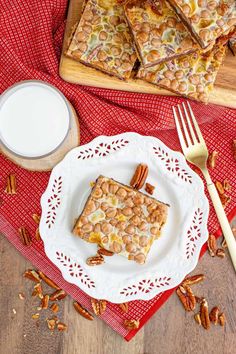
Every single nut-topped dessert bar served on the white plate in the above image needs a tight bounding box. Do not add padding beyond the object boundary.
[73,176,168,264]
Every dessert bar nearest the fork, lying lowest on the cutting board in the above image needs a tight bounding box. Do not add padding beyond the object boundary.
[137,42,226,103]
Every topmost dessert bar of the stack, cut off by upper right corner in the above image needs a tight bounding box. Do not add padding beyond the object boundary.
[168,0,236,48]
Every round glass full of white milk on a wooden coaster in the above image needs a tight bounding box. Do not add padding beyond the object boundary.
[0,80,72,159]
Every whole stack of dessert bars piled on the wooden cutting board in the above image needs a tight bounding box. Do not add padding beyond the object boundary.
[66,0,236,103]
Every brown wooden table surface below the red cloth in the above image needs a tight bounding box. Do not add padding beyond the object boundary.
[0,223,236,354]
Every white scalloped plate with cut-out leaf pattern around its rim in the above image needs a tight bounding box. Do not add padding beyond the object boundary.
[40,133,209,303]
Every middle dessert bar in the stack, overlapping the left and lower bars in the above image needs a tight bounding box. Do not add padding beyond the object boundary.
[124,0,199,67]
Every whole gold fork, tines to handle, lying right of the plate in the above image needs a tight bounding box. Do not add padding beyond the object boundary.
[172,102,236,271]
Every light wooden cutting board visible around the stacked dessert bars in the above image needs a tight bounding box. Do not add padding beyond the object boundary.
[59,0,236,108]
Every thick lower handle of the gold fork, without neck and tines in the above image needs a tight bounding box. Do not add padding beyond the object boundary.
[207,180,236,271]
